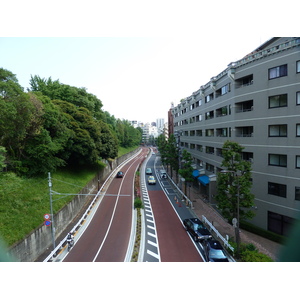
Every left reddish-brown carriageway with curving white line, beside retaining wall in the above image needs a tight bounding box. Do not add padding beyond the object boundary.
[63,148,147,262]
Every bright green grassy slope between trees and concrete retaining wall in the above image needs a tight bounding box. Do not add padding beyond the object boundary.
[0,147,136,246]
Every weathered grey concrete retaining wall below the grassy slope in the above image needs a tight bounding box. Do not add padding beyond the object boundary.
[9,149,139,262]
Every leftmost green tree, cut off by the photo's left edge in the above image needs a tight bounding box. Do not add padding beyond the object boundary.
[0,69,43,171]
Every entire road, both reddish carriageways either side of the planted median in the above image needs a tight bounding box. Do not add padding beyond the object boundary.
[57,148,203,262]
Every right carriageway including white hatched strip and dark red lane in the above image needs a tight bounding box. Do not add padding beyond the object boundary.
[142,149,203,262]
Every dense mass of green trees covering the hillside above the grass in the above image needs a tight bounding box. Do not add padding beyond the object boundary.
[0,68,142,176]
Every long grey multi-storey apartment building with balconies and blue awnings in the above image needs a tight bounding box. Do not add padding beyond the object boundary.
[169,37,300,235]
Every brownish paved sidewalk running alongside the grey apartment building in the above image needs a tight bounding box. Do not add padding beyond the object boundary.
[172,176,282,261]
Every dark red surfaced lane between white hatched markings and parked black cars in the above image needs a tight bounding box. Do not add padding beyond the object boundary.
[148,190,203,262]
